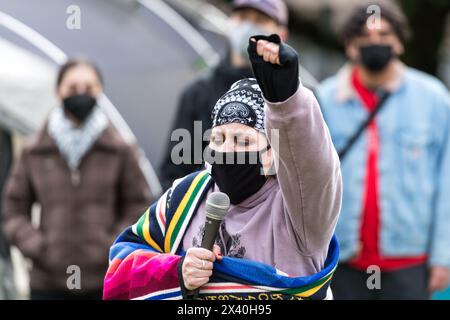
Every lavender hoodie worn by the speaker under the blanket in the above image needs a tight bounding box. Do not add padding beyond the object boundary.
[182,84,342,276]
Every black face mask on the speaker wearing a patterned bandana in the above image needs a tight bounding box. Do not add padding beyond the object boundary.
[207,147,270,204]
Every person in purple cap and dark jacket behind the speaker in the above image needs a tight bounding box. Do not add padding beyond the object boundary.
[160,0,288,189]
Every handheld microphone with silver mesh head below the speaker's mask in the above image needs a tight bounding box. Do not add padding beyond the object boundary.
[193,192,230,299]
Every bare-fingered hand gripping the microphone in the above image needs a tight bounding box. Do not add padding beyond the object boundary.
[181,245,222,291]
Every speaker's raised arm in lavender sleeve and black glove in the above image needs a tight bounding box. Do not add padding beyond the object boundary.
[249,36,342,255]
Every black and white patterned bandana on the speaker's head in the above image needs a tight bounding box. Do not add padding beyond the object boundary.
[211,78,264,133]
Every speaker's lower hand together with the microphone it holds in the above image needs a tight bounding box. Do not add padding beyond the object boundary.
[182,192,230,294]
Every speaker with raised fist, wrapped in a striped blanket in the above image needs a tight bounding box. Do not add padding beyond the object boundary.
[104,34,342,299]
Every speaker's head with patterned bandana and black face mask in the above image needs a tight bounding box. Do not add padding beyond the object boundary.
[205,79,276,204]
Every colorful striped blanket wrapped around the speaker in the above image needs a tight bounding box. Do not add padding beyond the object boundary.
[103,171,339,300]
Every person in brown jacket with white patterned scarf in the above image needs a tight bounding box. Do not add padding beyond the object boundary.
[2,60,151,299]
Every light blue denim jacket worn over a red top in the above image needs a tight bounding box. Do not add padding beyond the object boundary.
[317,63,450,266]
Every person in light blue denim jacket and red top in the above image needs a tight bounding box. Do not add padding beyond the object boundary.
[318,1,450,299]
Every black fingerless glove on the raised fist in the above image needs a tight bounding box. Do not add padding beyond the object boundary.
[247,34,300,102]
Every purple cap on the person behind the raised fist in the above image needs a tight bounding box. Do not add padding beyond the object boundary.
[232,0,289,26]
